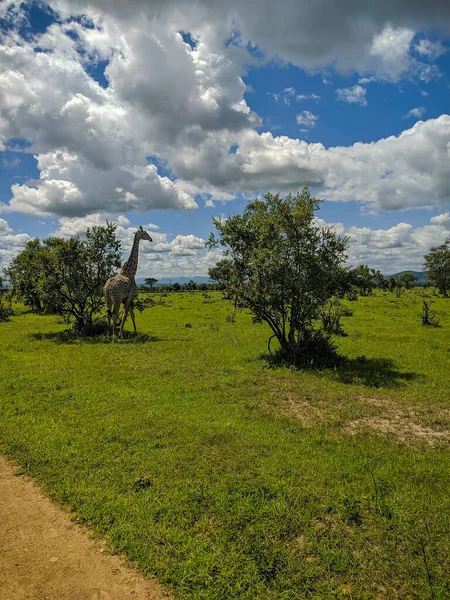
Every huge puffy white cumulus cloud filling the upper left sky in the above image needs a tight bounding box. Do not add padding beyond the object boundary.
[0,11,253,216]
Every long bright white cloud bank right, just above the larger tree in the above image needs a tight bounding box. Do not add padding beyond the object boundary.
[220,115,450,210]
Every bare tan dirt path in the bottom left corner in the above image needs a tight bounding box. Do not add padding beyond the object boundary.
[0,457,168,600]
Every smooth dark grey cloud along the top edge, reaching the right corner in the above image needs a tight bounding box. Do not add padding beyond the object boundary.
[44,0,450,79]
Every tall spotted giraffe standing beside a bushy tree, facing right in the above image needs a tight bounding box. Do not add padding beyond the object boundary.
[103,226,152,341]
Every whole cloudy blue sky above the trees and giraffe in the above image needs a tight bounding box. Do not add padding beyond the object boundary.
[0,0,450,277]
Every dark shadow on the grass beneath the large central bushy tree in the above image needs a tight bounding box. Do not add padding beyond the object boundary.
[262,353,424,388]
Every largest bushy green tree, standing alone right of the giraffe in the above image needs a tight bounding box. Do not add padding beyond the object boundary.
[208,187,347,364]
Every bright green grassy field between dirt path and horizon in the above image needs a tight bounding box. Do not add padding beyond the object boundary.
[0,291,450,600]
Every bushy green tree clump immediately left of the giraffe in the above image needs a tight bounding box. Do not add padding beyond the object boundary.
[7,224,121,333]
